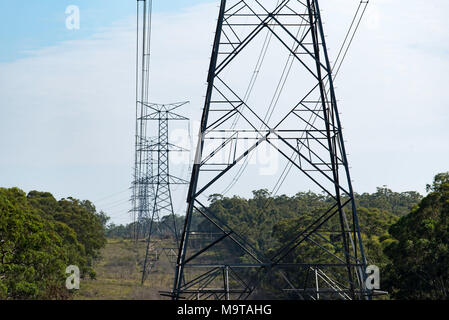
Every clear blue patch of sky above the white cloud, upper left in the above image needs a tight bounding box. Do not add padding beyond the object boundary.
[0,0,213,62]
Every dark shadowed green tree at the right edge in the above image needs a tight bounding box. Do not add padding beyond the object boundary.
[384,173,449,299]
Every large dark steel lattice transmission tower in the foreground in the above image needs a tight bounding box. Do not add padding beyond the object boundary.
[169,0,372,299]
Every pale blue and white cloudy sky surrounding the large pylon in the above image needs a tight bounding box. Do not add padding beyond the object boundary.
[0,0,449,223]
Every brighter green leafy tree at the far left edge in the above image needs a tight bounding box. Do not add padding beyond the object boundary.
[0,188,68,299]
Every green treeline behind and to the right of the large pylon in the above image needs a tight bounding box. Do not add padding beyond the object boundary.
[108,173,449,299]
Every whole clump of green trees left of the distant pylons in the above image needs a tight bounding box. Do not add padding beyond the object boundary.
[0,188,108,299]
